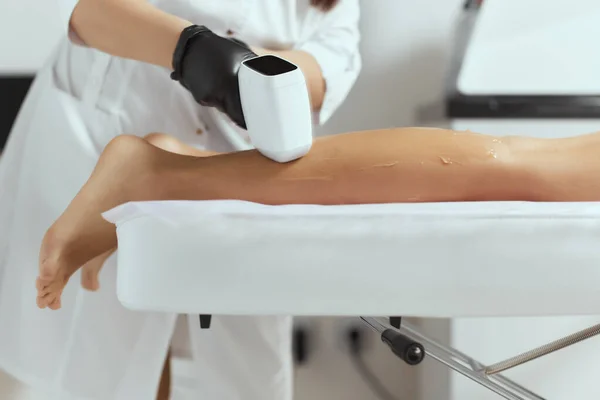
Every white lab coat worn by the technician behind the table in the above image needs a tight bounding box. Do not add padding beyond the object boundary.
[0,0,361,400]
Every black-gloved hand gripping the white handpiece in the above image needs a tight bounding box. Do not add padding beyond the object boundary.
[171,25,257,129]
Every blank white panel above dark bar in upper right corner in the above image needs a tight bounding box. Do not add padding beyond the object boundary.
[458,0,600,95]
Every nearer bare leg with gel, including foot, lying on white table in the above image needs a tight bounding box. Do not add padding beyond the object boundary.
[38,128,600,308]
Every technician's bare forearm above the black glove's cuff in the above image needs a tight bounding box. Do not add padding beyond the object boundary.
[71,0,191,69]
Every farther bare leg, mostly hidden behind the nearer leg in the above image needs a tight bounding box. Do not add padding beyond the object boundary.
[81,133,219,291]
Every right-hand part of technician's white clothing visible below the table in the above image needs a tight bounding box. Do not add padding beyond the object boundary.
[188,315,293,400]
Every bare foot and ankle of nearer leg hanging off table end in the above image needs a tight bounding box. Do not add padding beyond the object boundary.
[36,135,161,310]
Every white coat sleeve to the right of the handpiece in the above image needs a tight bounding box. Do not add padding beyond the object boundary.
[298,0,362,125]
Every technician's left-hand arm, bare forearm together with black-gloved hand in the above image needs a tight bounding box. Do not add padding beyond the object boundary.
[70,0,256,128]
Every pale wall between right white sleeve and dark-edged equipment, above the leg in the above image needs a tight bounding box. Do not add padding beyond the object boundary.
[322,0,462,134]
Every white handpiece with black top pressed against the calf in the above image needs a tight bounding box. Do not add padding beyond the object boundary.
[238,55,313,163]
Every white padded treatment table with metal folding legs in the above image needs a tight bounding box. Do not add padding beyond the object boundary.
[104,200,600,400]
